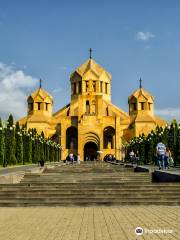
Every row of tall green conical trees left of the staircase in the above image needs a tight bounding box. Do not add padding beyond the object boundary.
[0,114,59,167]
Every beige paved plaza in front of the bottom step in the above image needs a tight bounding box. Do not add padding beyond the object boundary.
[0,206,180,240]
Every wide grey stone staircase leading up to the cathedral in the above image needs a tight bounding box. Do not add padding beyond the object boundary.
[0,163,180,207]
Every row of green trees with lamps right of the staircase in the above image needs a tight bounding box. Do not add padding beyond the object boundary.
[125,120,180,164]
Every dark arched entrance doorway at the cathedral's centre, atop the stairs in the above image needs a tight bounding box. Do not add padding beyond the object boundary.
[84,142,98,161]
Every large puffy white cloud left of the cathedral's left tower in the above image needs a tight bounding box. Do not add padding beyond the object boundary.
[0,62,37,118]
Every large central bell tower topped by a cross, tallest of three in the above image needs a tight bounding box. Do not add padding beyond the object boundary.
[70,52,111,115]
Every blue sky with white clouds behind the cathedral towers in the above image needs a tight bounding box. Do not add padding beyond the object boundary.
[0,0,180,120]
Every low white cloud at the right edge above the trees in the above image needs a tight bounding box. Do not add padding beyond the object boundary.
[155,107,180,120]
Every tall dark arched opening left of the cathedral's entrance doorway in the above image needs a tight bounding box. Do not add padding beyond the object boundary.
[66,127,78,149]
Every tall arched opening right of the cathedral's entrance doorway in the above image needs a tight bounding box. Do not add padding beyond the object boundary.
[103,127,115,149]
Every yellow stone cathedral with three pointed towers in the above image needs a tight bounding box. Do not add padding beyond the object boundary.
[19,58,166,160]
